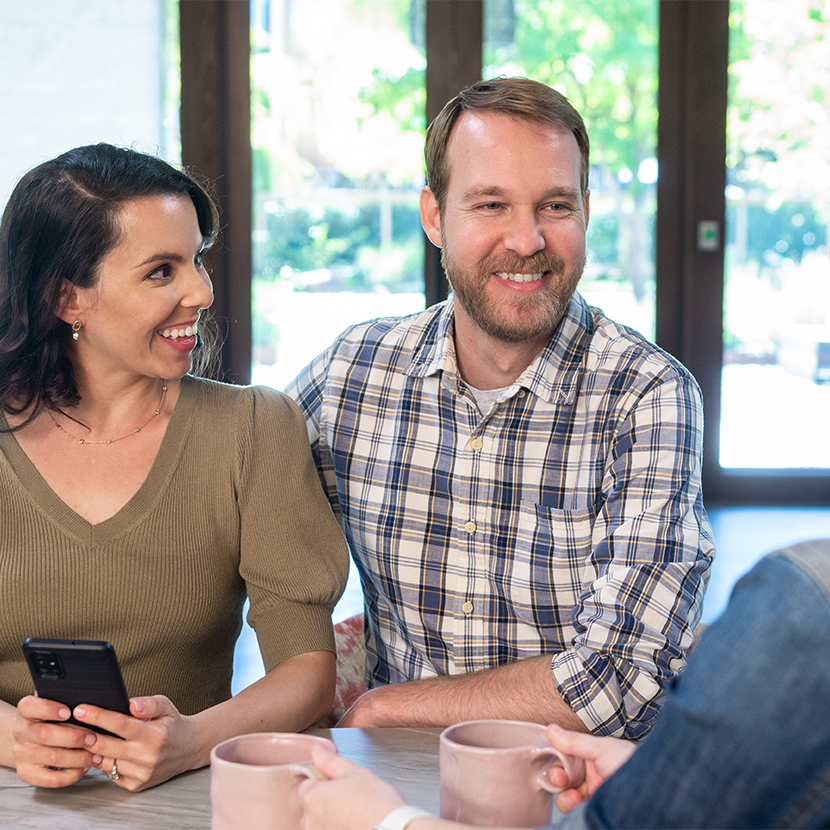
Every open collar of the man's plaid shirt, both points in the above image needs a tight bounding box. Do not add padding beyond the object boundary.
[406,292,595,405]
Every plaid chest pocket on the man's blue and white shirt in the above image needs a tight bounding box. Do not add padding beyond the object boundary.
[507,504,594,628]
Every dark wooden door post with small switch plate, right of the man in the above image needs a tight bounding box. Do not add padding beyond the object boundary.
[655,0,729,495]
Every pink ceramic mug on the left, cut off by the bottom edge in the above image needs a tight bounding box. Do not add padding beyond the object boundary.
[210,732,336,830]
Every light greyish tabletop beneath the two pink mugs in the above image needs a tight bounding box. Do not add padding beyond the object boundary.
[0,728,441,830]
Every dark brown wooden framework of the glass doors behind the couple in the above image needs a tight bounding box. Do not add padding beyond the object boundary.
[179,0,830,505]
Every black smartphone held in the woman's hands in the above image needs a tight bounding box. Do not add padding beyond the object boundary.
[23,637,130,735]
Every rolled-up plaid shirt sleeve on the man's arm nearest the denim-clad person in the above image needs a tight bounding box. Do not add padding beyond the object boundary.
[552,374,714,738]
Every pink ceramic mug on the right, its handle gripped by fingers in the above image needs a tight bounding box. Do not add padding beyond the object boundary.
[440,720,582,827]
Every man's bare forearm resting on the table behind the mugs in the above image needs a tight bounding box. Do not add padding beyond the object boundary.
[338,654,587,732]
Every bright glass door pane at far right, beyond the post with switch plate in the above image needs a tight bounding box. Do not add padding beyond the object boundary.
[719,0,830,473]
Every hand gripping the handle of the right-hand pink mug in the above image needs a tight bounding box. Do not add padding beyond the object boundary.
[548,724,637,813]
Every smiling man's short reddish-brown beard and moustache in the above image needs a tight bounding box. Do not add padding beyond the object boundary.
[441,248,585,343]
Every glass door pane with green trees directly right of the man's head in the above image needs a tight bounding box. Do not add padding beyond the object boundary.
[483,0,659,339]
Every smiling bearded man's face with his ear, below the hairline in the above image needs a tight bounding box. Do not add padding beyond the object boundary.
[422,112,588,342]
